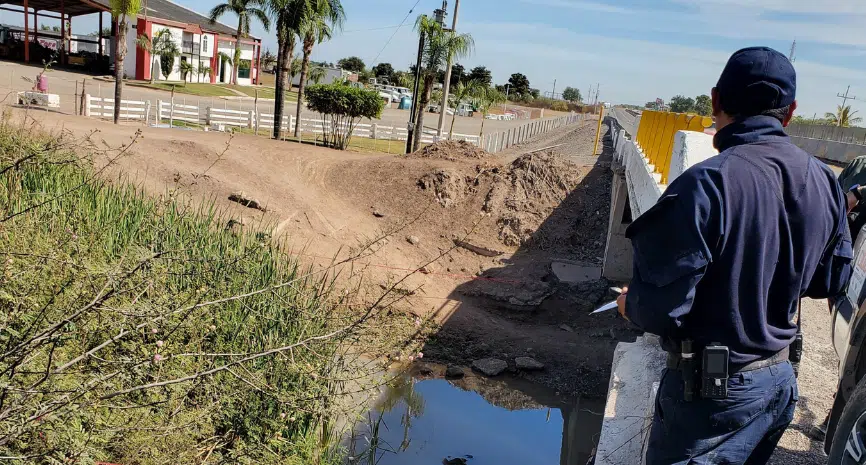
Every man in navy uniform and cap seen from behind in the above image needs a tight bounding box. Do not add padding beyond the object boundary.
[619,47,852,465]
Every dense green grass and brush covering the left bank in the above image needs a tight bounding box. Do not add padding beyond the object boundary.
[0,115,416,465]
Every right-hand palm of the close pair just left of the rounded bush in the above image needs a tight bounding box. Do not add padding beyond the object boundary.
[295,0,346,137]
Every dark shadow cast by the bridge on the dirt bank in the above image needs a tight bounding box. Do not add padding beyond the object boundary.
[424,119,639,397]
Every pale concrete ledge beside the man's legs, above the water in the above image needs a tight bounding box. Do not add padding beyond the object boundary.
[595,334,666,465]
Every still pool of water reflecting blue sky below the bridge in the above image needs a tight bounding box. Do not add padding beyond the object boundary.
[349,366,604,465]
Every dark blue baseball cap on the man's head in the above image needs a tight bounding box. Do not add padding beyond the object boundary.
[716,47,797,115]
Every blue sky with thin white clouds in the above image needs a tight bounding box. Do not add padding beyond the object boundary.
[0,0,866,116]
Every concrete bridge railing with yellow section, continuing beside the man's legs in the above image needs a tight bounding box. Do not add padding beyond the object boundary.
[595,112,717,465]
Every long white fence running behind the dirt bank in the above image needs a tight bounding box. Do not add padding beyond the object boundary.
[84,94,586,153]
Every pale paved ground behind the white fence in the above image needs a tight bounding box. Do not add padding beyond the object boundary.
[0,61,564,135]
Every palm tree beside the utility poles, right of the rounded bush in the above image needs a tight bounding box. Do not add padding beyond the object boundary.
[412,15,475,151]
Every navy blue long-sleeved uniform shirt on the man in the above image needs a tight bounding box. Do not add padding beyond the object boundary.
[626,116,853,364]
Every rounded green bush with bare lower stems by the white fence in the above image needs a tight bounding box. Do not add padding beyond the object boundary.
[304,83,385,150]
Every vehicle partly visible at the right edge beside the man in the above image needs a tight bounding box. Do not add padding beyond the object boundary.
[824,227,866,465]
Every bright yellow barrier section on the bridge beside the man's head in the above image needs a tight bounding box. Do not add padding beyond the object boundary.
[635,111,713,184]
